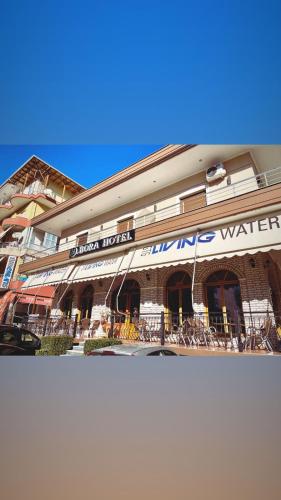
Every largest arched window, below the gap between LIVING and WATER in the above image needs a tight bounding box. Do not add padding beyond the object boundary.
[205,270,242,332]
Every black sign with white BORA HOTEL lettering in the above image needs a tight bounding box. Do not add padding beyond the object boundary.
[69,229,135,259]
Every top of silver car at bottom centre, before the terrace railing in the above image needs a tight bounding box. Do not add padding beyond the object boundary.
[88,344,177,356]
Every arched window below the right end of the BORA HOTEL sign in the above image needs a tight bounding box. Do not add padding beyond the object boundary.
[111,280,140,316]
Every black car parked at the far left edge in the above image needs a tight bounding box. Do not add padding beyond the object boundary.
[0,325,41,356]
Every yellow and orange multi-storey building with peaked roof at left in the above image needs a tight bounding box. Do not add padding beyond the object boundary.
[0,156,84,322]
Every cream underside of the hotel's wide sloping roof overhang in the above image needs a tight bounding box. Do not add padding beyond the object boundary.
[29,145,268,236]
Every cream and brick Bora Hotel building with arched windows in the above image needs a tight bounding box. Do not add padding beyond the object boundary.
[20,145,281,338]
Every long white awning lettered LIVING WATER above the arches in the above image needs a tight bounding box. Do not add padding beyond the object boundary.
[72,215,281,282]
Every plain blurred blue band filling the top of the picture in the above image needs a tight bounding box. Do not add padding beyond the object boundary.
[0,0,281,144]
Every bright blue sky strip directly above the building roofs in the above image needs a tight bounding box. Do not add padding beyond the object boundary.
[0,145,161,187]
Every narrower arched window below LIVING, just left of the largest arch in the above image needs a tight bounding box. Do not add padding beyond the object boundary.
[166,271,193,324]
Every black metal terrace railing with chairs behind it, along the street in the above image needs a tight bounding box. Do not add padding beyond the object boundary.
[20,311,281,352]
